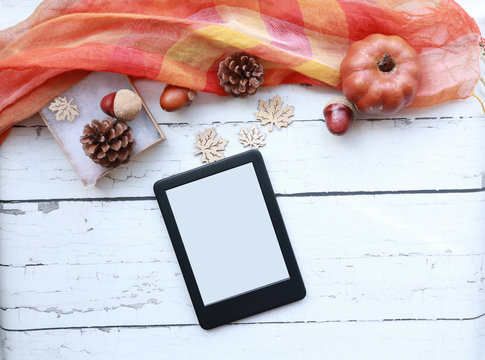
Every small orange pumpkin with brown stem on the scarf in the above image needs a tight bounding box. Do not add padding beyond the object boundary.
[340,34,421,115]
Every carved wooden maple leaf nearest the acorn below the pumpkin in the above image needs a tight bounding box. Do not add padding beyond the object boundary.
[254,95,295,131]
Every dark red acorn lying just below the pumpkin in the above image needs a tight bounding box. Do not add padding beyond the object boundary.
[323,96,357,135]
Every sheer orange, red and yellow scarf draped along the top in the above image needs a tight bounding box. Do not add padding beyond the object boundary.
[0,0,480,133]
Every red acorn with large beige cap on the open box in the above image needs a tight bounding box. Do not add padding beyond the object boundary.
[99,89,143,121]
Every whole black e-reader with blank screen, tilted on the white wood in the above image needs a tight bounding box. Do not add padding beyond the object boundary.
[154,150,305,329]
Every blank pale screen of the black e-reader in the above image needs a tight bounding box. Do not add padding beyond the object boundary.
[167,163,289,305]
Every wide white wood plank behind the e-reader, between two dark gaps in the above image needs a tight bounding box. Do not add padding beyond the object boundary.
[0,193,485,328]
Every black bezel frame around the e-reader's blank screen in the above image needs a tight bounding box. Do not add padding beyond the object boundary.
[153,150,306,330]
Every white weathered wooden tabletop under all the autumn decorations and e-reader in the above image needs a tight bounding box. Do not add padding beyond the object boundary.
[0,0,485,360]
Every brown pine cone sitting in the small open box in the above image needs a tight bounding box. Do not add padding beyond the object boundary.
[80,117,135,167]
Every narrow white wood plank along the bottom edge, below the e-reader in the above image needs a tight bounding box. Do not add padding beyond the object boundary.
[2,318,485,360]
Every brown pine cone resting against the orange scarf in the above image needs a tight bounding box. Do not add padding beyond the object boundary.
[217,52,264,98]
